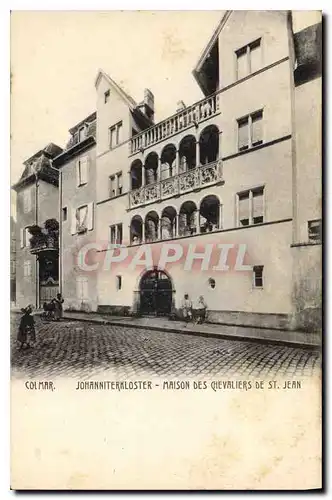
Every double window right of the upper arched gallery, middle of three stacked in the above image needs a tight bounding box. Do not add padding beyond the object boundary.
[237,110,263,151]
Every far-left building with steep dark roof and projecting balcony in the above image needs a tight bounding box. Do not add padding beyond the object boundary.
[13,143,62,307]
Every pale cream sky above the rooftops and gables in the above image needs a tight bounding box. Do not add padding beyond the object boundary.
[11,11,320,213]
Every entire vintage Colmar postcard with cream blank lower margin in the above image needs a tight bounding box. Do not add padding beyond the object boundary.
[11,10,322,490]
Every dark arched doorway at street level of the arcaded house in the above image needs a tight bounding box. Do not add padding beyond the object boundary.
[139,269,173,316]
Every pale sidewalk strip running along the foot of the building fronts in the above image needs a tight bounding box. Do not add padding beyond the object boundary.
[55,311,321,347]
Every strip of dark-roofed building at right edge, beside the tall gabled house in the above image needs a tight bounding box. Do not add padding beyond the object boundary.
[292,17,323,329]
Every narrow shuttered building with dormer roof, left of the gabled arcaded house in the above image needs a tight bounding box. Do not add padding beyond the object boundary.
[53,112,98,312]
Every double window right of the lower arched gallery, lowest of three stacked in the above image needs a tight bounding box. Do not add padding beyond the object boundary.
[237,186,264,226]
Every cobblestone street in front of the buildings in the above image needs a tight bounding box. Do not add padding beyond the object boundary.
[11,315,320,378]
